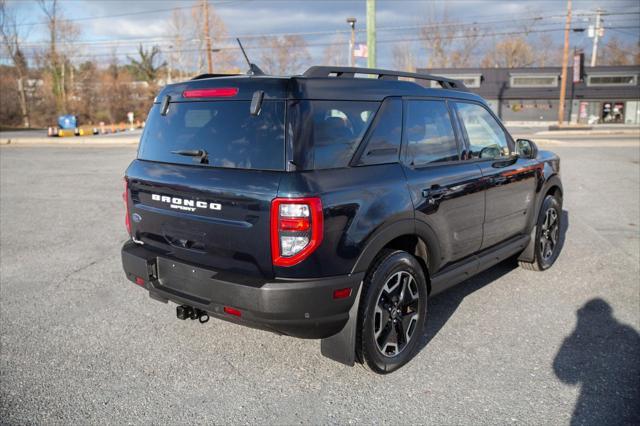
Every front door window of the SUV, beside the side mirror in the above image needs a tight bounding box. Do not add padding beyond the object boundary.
[456,102,509,158]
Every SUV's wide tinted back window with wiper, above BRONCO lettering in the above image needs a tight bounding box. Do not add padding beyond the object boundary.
[138,100,285,170]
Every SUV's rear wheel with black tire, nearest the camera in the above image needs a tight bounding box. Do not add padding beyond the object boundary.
[356,249,427,374]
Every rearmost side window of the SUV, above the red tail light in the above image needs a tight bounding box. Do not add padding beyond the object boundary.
[289,100,380,170]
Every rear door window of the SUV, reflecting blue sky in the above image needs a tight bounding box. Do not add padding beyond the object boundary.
[405,100,459,166]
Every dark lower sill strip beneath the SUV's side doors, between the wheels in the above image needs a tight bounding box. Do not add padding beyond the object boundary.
[430,235,531,296]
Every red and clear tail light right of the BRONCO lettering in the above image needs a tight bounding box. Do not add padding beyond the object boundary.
[271,198,323,266]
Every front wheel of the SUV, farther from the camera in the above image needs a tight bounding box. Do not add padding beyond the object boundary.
[518,195,563,271]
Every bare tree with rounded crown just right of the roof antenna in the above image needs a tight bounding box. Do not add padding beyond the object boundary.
[260,35,311,75]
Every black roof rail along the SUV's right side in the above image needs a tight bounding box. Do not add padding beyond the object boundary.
[302,66,468,92]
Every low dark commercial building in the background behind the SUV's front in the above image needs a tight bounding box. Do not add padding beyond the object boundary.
[418,66,640,124]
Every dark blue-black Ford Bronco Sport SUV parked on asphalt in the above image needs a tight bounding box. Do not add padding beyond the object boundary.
[122,67,562,373]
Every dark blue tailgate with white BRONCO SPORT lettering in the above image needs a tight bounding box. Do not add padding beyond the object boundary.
[127,160,281,278]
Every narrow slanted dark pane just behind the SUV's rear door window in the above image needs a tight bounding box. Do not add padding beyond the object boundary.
[356,99,402,166]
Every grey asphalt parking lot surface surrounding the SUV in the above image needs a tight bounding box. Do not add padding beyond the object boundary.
[0,136,640,424]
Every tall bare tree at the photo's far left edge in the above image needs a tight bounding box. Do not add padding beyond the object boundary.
[0,0,31,128]
